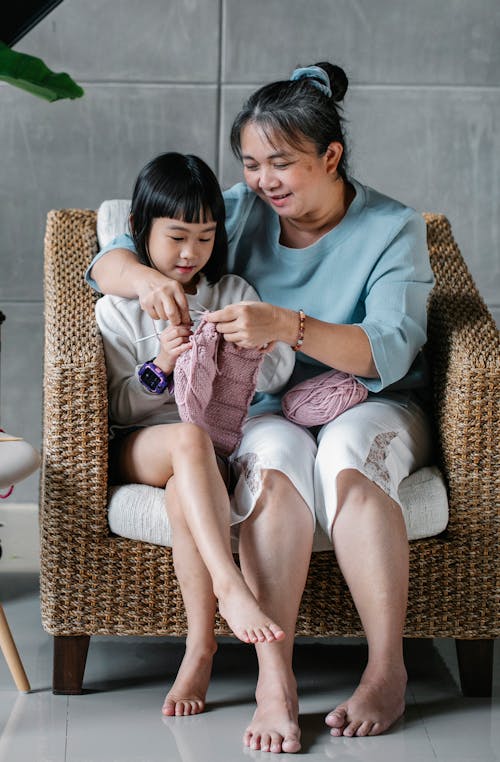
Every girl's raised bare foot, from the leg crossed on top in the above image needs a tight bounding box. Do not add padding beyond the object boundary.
[214,578,285,643]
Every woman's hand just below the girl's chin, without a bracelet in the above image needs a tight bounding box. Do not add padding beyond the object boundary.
[137,267,191,325]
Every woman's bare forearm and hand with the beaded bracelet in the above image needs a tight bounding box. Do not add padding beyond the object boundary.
[207,302,378,378]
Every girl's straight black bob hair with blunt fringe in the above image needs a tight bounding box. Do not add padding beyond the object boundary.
[130,152,227,283]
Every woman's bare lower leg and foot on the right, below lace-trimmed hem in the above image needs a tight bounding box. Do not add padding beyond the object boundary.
[326,469,409,736]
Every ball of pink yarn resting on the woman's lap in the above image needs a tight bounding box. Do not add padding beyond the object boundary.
[281,370,368,426]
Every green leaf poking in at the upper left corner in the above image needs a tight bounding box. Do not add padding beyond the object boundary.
[0,42,84,101]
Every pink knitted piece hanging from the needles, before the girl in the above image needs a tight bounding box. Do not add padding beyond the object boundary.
[174,319,264,455]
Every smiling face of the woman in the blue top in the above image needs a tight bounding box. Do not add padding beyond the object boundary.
[241,122,342,222]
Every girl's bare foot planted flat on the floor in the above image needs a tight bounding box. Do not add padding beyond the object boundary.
[161,641,217,717]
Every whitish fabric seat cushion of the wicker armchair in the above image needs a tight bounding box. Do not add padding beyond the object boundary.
[108,466,448,551]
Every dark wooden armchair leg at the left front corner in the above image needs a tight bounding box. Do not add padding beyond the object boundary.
[52,635,90,696]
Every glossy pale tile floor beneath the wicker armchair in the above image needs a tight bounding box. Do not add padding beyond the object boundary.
[0,503,500,762]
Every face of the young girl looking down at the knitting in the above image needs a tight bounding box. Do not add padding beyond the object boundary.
[148,217,217,293]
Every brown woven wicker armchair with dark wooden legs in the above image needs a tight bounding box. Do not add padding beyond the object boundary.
[41,209,500,696]
